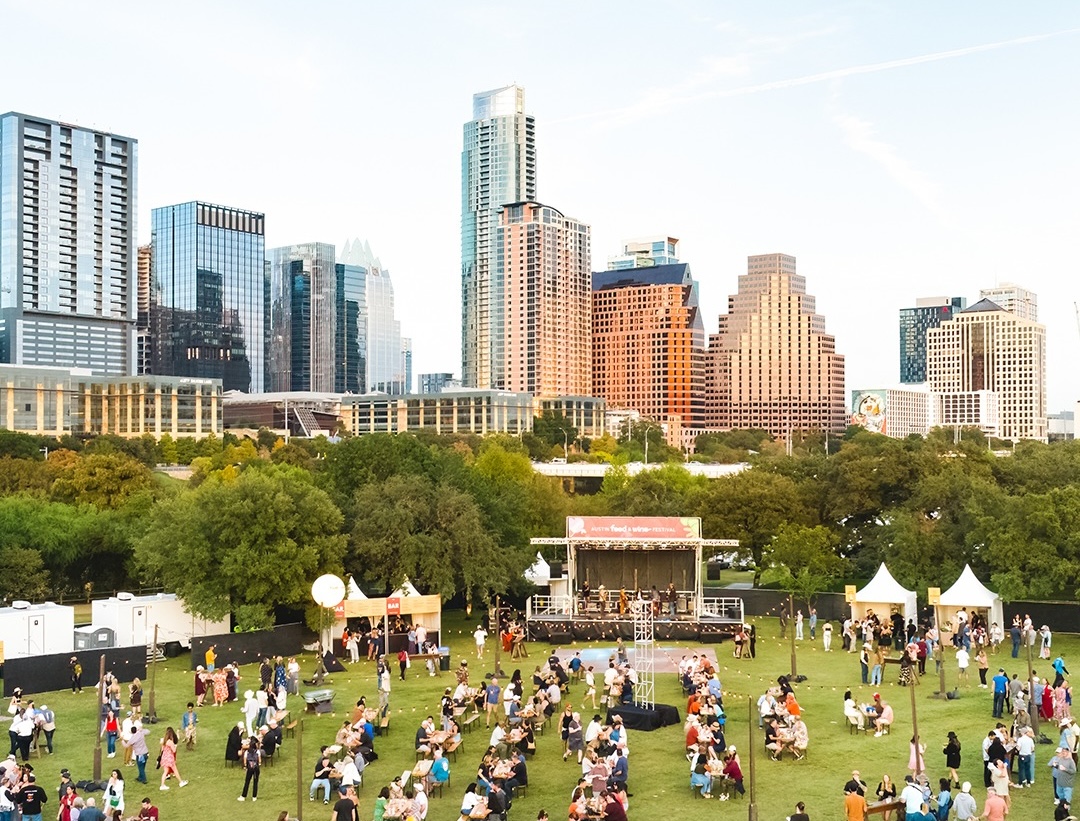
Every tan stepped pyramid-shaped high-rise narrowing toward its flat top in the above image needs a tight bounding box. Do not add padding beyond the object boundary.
[706,254,848,439]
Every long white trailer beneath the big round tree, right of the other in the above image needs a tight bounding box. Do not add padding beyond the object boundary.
[91,593,230,648]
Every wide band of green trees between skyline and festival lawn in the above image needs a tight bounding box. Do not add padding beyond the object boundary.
[0,429,1080,628]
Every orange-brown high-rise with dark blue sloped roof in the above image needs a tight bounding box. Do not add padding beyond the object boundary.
[593,263,705,428]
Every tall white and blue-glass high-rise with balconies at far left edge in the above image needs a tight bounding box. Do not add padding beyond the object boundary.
[0,112,138,375]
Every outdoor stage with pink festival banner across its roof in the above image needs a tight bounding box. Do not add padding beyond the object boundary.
[526,516,743,644]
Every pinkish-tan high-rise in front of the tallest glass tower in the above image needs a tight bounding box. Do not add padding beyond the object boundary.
[495,202,592,396]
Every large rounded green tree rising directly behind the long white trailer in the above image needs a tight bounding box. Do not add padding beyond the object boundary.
[135,466,346,629]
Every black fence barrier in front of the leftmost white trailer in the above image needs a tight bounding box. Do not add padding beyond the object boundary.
[3,645,146,706]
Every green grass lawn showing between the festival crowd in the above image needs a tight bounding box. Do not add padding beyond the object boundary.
[8,613,1080,821]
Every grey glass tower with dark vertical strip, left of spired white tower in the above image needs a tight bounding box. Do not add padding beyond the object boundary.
[269,242,337,393]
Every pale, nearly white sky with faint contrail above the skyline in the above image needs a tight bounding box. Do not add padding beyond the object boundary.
[0,0,1080,411]
